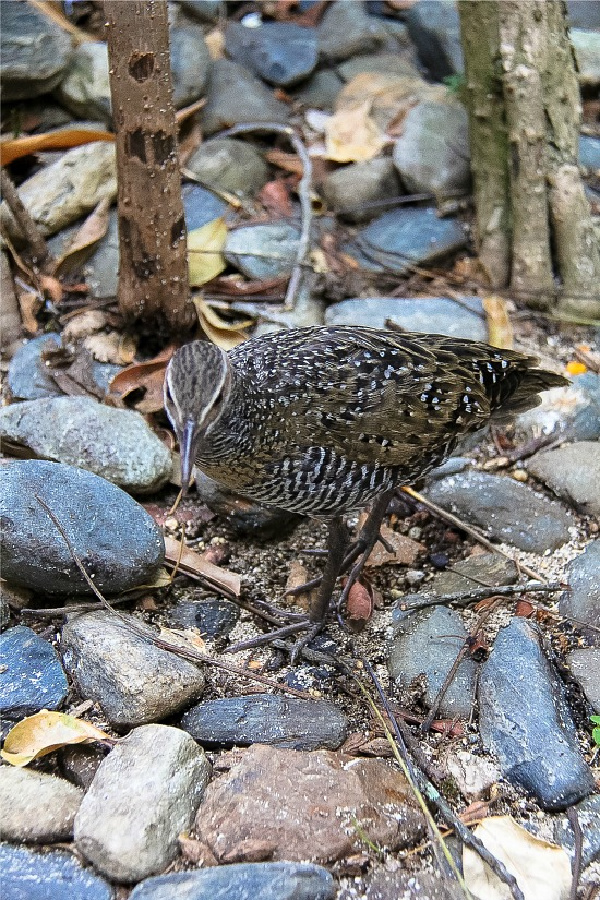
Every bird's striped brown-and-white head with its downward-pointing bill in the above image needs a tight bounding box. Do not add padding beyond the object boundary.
[164,341,231,491]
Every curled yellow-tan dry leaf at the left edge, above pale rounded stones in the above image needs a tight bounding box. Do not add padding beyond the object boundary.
[0,709,112,767]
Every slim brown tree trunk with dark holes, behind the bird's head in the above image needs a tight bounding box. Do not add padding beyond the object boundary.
[104,0,195,334]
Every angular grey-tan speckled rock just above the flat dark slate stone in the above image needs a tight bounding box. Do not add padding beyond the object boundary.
[62,610,204,728]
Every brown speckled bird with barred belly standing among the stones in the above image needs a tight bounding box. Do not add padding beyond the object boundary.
[164,326,568,652]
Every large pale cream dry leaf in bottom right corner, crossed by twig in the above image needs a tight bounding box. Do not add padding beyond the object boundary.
[463,816,572,900]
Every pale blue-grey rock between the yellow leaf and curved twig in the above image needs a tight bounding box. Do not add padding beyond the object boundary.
[225,222,300,279]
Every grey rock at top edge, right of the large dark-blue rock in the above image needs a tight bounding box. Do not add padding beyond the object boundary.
[318,3,386,60]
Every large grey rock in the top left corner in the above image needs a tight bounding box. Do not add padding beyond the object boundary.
[0,3,72,103]
